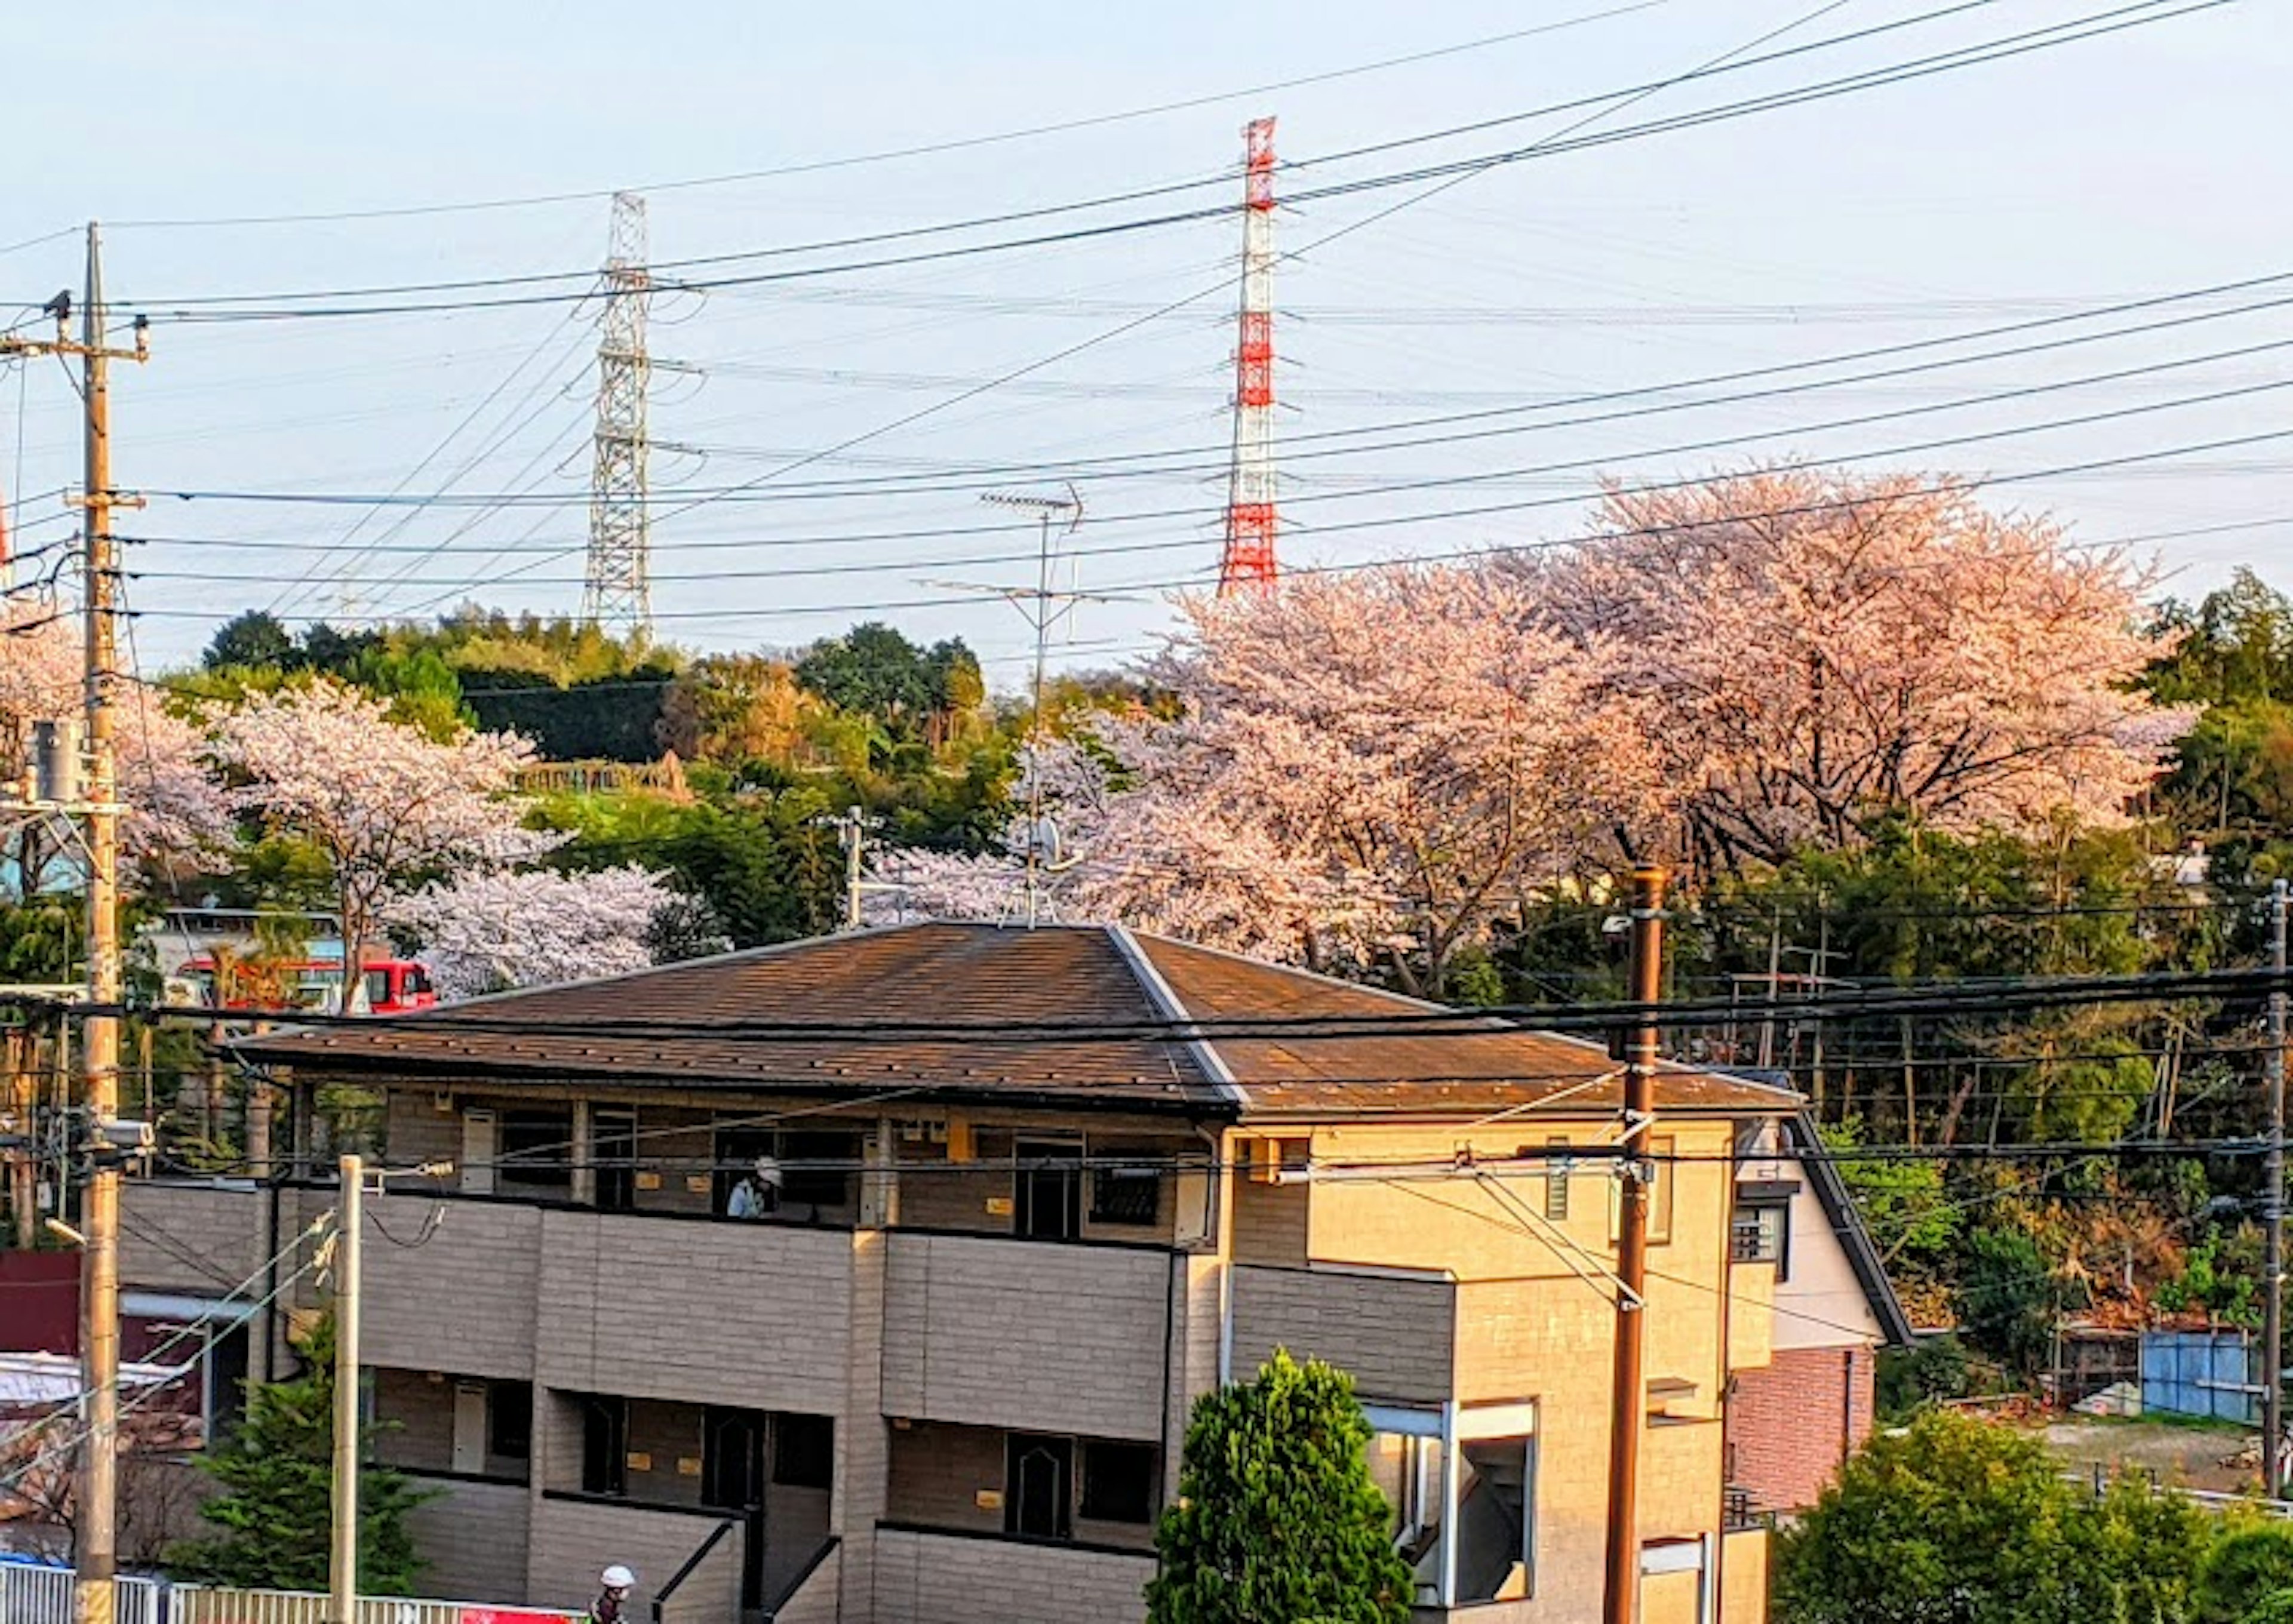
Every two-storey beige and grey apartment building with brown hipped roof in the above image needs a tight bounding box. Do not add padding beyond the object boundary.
[122,924,1796,1624]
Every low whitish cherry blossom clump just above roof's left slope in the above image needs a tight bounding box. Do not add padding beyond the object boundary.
[383,867,706,998]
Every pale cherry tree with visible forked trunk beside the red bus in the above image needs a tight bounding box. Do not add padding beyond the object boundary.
[211,681,560,1007]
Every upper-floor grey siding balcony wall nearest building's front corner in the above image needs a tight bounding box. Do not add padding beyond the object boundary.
[883,1234,1169,1441]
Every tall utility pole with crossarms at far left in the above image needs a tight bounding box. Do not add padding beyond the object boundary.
[0,223,151,1624]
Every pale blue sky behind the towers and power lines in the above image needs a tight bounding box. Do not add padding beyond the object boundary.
[0,0,2293,688]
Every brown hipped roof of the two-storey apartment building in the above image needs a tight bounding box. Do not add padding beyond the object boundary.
[236,922,1798,1119]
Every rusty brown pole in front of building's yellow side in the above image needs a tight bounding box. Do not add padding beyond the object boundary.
[1600,865,1665,1624]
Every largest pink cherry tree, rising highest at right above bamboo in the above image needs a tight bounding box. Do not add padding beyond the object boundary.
[1504,470,2187,867]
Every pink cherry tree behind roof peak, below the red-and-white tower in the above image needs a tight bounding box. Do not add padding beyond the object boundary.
[883,567,1655,994]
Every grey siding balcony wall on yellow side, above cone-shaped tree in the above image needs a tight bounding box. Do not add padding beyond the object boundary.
[1234,1266,1456,1401]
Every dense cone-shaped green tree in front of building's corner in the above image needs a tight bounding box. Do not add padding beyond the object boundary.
[1146,1349,1412,1624]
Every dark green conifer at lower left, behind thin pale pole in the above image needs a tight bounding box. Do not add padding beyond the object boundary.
[167,1314,436,1597]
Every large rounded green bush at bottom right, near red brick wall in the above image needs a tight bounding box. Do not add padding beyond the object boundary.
[1775,1411,2215,1624]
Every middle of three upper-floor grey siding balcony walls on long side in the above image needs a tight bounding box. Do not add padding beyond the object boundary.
[537,1211,851,1415]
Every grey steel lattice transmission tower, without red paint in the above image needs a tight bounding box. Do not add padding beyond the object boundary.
[580,193,653,638]
